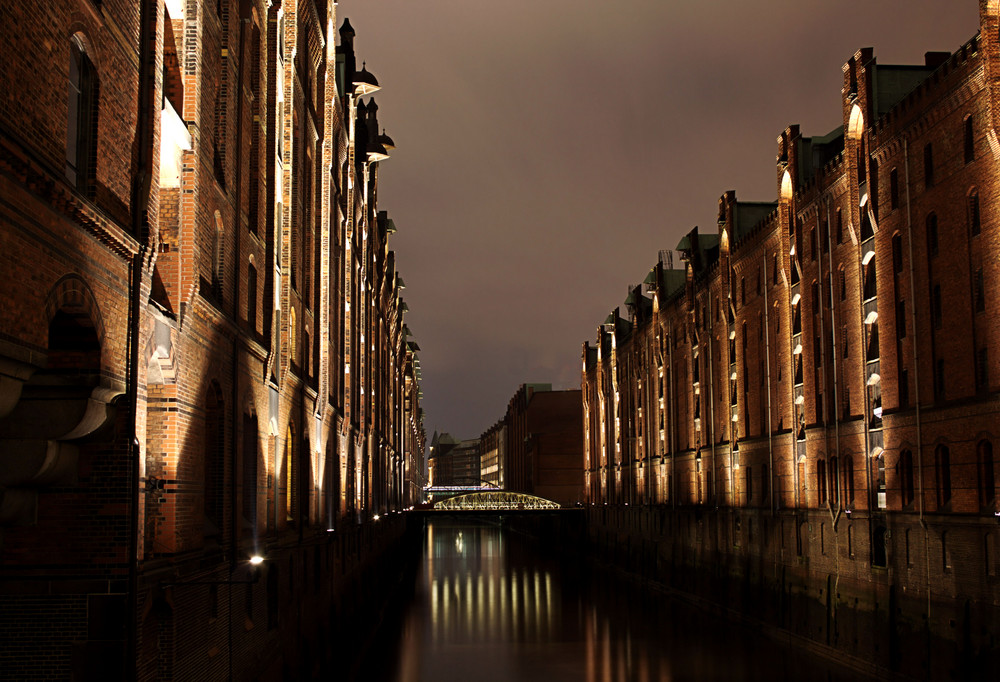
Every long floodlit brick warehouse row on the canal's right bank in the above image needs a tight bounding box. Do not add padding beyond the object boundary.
[582,0,1000,672]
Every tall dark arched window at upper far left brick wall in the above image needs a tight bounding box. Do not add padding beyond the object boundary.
[66,36,98,193]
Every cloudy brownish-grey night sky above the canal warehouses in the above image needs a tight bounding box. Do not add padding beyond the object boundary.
[338,0,978,438]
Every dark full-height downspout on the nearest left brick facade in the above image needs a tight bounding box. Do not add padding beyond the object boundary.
[125,0,159,680]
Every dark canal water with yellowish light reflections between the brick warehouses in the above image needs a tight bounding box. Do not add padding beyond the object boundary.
[354,519,868,682]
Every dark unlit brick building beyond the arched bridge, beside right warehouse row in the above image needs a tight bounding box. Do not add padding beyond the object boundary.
[479,384,583,505]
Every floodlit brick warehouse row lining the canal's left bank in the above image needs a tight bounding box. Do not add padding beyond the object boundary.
[0,0,424,679]
